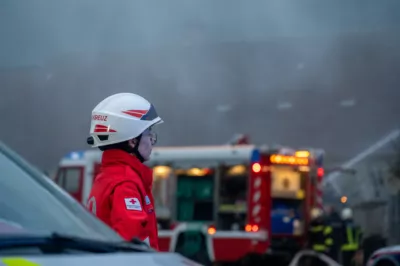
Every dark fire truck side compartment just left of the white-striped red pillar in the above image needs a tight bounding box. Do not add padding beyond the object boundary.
[220,165,248,205]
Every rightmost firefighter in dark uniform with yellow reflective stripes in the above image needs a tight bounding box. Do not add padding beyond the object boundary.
[340,208,362,266]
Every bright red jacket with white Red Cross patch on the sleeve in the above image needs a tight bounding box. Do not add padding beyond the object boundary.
[86,150,158,249]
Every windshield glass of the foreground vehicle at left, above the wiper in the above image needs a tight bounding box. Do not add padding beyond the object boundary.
[0,142,122,241]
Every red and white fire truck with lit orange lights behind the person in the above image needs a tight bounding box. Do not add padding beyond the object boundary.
[55,145,324,265]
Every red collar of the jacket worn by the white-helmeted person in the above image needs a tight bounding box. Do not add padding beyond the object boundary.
[101,149,153,189]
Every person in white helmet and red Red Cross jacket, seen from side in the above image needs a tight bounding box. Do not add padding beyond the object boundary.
[86,93,163,249]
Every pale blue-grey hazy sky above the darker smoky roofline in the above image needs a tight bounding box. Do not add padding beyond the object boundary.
[0,0,400,66]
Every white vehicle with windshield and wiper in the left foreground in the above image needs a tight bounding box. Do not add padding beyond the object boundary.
[0,142,198,266]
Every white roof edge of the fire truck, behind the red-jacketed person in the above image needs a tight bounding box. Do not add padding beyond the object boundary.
[60,145,255,167]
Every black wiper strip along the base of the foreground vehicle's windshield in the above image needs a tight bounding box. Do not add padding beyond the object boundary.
[0,233,154,254]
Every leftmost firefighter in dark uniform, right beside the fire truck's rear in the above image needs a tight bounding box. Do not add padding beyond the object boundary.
[308,208,333,254]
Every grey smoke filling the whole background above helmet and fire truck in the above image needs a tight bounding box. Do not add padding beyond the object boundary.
[0,0,400,168]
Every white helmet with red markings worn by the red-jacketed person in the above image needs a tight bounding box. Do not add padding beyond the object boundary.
[88,93,163,147]
